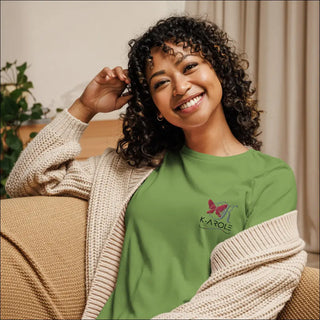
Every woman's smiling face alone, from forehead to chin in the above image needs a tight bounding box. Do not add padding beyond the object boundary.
[146,43,222,130]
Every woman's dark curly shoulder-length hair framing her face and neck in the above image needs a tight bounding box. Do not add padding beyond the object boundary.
[117,16,262,167]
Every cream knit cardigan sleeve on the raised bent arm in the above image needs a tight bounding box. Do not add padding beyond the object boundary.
[6,110,99,199]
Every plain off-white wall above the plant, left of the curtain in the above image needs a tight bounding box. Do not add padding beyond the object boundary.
[1,1,185,120]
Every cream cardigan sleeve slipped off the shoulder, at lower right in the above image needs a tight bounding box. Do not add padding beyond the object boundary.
[153,211,306,319]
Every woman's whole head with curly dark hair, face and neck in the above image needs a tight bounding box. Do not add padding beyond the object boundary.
[118,17,261,166]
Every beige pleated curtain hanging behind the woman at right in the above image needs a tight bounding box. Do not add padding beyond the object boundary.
[186,1,319,252]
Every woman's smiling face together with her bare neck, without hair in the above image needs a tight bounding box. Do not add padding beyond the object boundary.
[146,43,242,156]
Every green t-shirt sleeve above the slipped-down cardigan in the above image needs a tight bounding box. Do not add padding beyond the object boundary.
[245,160,297,229]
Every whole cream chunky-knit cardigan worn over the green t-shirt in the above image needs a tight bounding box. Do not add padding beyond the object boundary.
[6,111,306,319]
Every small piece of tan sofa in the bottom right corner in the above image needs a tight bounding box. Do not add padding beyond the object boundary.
[278,267,320,320]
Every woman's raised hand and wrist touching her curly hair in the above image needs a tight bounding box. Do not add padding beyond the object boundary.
[68,67,132,122]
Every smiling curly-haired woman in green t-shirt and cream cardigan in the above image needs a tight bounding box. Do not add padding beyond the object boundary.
[6,16,306,319]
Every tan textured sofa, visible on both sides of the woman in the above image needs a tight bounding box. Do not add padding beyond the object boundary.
[1,196,320,319]
